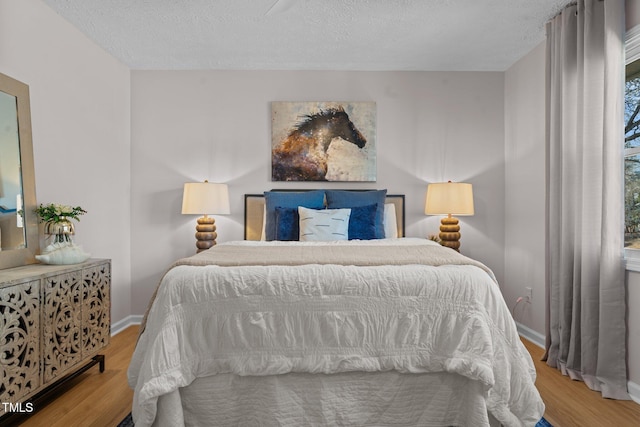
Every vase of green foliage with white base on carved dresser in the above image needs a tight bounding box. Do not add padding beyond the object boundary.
[36,203,90,264]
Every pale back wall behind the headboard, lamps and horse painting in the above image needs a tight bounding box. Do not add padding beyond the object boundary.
[131,71,504,314]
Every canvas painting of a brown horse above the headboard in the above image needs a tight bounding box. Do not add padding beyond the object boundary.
[271,102,376,182]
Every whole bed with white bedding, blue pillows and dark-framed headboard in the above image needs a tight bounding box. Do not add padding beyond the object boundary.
[128,190,544,427]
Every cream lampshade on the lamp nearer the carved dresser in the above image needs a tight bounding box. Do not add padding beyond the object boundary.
[182,181,231,215]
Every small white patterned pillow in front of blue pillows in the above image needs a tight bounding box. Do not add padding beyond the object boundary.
[298,206,351,242]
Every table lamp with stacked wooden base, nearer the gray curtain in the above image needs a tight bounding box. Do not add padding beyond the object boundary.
[424,181,473,252]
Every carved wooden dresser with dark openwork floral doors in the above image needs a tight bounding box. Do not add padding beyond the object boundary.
[0,259,111,424]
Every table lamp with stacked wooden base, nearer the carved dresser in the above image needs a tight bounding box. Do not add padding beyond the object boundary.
[182,181,231,252]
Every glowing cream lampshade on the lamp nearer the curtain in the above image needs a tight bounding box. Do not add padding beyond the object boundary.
[424,181,474,216]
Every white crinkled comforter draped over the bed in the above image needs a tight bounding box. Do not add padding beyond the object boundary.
[129,239,544,426]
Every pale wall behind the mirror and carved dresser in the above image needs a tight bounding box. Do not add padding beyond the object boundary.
[0,0,131,322]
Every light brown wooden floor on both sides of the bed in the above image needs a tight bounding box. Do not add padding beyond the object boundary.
[8,326,640,427]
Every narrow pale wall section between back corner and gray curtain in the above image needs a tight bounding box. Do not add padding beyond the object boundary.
[502,43,546,335]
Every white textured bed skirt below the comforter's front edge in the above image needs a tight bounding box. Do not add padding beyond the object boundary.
[153,371,493,427]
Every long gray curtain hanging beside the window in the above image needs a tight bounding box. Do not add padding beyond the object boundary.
[545,0,629,399]
